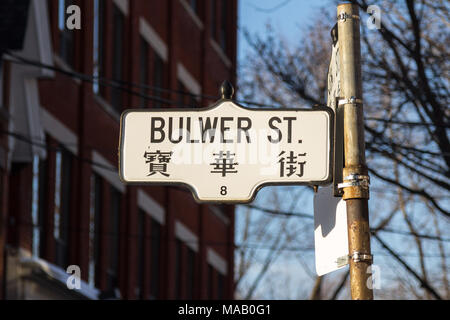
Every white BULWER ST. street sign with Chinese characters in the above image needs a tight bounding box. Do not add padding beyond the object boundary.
[119,100,333,202]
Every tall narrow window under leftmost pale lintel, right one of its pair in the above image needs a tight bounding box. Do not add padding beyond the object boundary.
[53,147,72,268]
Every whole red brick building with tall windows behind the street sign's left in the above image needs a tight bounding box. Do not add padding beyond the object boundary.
[0,0,237,299]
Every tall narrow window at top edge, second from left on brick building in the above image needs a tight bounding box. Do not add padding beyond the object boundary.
[92,0,105,95]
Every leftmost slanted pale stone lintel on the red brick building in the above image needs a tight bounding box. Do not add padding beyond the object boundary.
[41,107,78,154]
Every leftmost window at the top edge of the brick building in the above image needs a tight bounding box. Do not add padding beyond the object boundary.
[58,0,75,66]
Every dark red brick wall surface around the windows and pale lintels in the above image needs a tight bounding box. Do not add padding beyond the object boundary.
[0,0,237,299]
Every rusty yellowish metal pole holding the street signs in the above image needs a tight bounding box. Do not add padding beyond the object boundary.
[337,3,373,300]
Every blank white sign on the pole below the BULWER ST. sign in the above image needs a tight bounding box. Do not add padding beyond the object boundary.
[314,186,348,276]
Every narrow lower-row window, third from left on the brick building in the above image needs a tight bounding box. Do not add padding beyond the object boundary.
[88,174,103,287]
